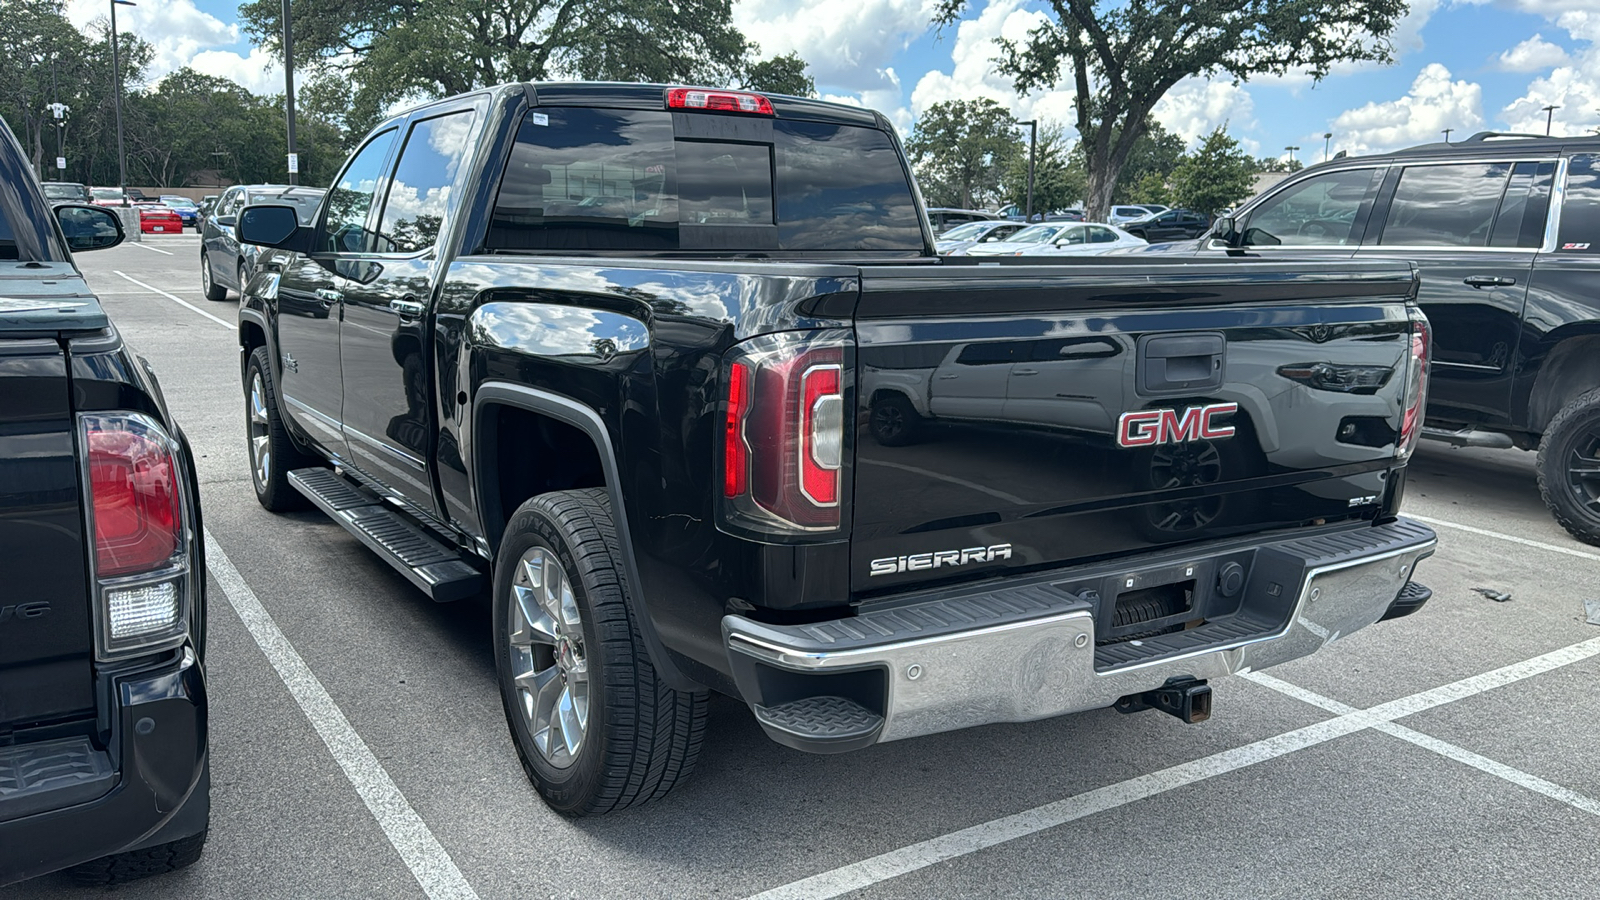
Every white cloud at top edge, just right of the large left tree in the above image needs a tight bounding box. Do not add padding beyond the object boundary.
[733,0,934,92]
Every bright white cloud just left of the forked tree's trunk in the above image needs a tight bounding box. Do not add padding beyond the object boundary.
[910,0,1075,133]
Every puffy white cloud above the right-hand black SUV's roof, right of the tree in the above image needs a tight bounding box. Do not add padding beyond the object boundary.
[1330,62,1483,154]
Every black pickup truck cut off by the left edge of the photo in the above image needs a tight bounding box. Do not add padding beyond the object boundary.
[0,112,211,894]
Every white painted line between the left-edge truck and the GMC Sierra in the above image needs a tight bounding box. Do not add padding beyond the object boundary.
[205,528,478,900]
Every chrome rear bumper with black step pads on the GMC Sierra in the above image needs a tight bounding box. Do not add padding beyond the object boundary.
[723,519,1435,753]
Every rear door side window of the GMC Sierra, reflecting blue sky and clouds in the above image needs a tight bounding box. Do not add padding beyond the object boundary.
[378,110,472,253]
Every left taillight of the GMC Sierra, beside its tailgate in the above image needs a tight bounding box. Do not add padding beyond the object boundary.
[720,331,851,540]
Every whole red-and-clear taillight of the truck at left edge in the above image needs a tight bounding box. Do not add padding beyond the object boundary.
[80,413,189,658]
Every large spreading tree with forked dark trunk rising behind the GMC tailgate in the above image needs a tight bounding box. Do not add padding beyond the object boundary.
[934,0,1406,218]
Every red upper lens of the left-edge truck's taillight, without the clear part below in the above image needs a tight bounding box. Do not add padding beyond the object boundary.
[83,415,184,578]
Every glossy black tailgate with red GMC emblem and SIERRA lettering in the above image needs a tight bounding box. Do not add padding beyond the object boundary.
[851,261,1414,596]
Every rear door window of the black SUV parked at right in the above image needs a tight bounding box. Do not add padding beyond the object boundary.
[1379,163,1510,247]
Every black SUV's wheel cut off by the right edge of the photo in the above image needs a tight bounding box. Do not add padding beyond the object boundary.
[1539,388,1600,544]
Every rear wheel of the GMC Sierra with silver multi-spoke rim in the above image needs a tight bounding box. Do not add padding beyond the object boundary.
[493,488,707,815]
